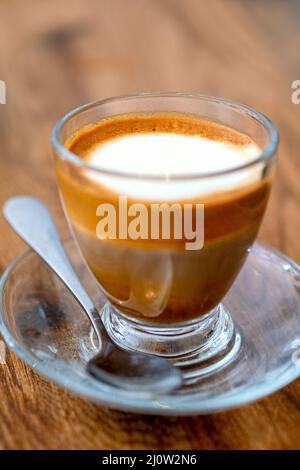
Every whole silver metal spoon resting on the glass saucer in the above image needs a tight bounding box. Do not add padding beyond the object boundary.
[3,196,182,395]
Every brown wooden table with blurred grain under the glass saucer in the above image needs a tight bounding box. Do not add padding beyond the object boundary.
[0,0,300,449]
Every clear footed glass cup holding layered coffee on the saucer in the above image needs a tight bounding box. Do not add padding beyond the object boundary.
[52,93,278,377]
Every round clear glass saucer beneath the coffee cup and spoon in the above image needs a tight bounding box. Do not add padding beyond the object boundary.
[0,240,300,415]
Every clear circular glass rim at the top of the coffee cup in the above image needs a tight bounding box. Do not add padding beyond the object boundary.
[51,92,279,181]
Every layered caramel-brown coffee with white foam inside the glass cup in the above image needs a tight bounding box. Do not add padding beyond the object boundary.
[56,113,270,324]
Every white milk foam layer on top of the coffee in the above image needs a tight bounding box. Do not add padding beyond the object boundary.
[86,133,262,199]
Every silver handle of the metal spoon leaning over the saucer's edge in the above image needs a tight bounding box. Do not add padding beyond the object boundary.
[3,196,107,341]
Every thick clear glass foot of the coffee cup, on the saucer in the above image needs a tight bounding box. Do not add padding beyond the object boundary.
[102,303,242,383]
